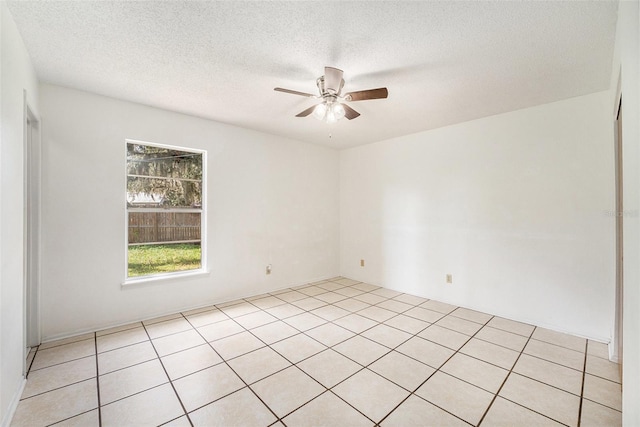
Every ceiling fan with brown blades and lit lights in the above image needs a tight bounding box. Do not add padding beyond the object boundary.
[273,67,389,123]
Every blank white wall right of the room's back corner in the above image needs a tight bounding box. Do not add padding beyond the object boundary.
[340,92,615,341]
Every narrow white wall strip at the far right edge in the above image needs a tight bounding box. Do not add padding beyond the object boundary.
[610,1,640,426]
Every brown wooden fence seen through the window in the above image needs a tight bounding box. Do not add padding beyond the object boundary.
[129,211,200,245]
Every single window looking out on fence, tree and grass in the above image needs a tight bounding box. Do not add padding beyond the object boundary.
[126,141,206,279]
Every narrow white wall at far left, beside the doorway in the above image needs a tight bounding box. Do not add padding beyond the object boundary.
[0,1,38,425]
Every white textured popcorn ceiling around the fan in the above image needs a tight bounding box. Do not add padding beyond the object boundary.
[8,1,618,148]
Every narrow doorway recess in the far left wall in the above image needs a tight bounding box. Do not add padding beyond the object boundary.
[23,93,41,371]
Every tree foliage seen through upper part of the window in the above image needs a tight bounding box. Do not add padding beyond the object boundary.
[127,143,202,207]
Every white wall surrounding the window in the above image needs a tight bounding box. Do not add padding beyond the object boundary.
[40,85,339,340]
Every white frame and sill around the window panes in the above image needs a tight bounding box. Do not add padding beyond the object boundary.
[122,139,209,286]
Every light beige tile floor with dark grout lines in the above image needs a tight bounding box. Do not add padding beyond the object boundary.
[12,277,621,427]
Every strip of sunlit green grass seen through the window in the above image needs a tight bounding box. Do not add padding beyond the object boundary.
[128,244,201,277]
